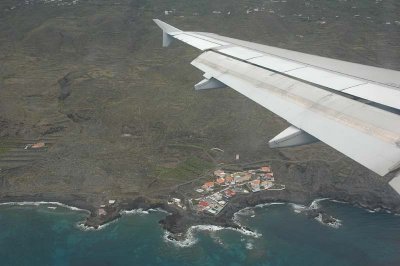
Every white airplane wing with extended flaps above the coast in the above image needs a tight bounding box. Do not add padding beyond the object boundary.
[154,19,400,194]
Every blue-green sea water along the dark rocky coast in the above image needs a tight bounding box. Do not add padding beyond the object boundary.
[0,201,400,266]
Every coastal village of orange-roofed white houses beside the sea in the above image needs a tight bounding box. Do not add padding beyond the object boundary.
[169,166,285,215]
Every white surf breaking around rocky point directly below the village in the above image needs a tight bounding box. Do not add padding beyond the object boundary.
[163,225,262,247]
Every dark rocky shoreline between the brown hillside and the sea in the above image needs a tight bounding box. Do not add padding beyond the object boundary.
[0,187,400,241]
